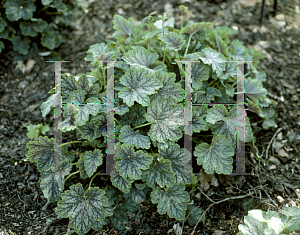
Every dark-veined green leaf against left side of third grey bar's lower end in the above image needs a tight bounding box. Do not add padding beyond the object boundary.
[158,144,193,184]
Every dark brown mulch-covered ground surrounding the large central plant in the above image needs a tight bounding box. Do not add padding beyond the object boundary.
[0,0,300,235]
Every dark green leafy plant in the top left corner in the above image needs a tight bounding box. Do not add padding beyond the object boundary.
[0,0,88,60]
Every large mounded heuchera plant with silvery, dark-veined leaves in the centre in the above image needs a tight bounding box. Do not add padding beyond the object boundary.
[26,6,276,234]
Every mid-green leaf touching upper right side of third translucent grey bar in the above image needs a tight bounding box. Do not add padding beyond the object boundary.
[191,62,209,90]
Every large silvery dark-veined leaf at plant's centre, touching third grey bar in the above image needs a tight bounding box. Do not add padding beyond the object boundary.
[145,98,184,143]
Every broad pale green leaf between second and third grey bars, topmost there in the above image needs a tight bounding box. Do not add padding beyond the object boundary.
[123,46,166,73]
